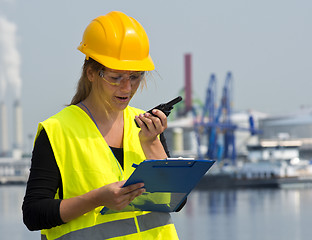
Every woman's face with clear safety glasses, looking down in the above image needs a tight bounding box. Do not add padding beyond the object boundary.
[92,68,144,111]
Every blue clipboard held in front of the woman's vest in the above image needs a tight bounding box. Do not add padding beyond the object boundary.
[101,158,215,214]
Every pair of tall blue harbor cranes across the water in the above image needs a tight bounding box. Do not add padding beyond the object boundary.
[192,72,258,165]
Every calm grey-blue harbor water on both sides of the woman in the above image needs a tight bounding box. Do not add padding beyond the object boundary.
[0,186,312,240]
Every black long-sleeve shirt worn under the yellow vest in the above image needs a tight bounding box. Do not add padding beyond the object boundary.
[22,129,176,231]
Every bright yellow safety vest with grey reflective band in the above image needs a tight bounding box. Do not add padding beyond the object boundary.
[37,105,178,240]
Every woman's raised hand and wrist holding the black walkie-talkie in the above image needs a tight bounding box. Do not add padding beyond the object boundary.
[135,109,167,159]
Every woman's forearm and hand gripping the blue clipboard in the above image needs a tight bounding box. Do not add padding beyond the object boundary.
[60,181,145,222]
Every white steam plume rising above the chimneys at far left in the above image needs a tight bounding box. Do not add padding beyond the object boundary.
[0,16,22,99]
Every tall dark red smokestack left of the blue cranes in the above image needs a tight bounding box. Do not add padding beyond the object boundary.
[184,53,192,113]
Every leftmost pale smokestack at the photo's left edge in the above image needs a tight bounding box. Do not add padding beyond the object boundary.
[0,101,9,156]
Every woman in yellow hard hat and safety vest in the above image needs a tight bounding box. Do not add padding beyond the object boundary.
[23,12,178,240]
